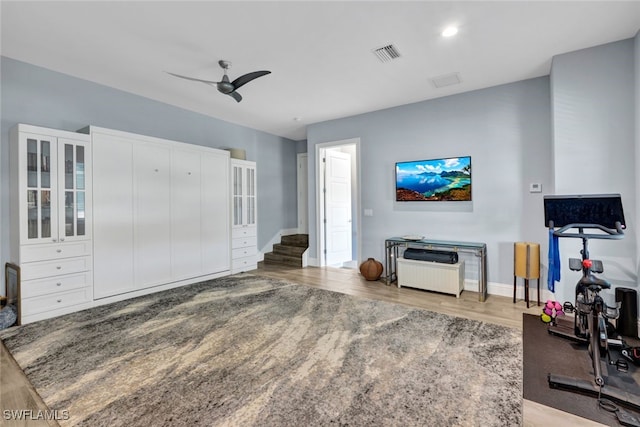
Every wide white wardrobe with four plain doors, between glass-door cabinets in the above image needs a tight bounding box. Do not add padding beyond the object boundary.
[89,127,231,299]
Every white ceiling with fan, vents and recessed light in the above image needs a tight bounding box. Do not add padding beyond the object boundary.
[0,1,640,140]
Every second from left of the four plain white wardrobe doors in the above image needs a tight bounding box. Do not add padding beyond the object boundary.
[133,142,171,288]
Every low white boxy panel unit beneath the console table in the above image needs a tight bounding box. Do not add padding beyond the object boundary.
[397,258,464,298]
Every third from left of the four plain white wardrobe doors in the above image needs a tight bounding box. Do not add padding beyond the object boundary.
[171,150,202,279]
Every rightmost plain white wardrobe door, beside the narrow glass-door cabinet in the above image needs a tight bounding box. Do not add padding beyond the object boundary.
[201,155,231,273]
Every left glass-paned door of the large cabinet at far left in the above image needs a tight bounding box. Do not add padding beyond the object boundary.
[21,135,57,243]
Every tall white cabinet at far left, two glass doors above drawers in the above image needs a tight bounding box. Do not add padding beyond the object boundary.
[9,124,93,323]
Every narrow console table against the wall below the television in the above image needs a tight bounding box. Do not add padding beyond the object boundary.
[384,237,487,302]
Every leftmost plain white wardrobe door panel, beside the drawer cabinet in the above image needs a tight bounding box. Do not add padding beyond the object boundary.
[93,134,134,298]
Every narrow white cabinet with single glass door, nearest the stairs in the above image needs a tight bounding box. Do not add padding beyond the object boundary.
[231,159,258,274]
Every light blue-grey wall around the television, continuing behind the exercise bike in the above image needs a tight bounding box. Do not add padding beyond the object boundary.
[307,36,640,301]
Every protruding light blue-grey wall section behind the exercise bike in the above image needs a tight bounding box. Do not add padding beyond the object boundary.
[551,39,638,308]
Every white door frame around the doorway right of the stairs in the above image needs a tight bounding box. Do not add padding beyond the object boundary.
[315,138,362,267]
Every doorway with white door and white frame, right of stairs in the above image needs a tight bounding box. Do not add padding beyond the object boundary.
[316,138,361,268]
